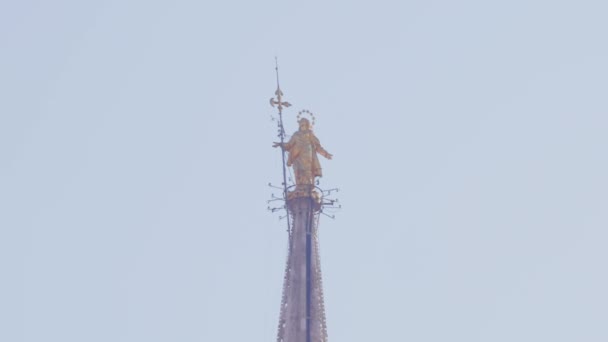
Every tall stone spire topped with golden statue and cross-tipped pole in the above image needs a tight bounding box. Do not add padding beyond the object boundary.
[269,65,339,342]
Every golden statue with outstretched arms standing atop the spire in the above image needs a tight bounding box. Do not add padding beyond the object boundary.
[272,118,332,192]
